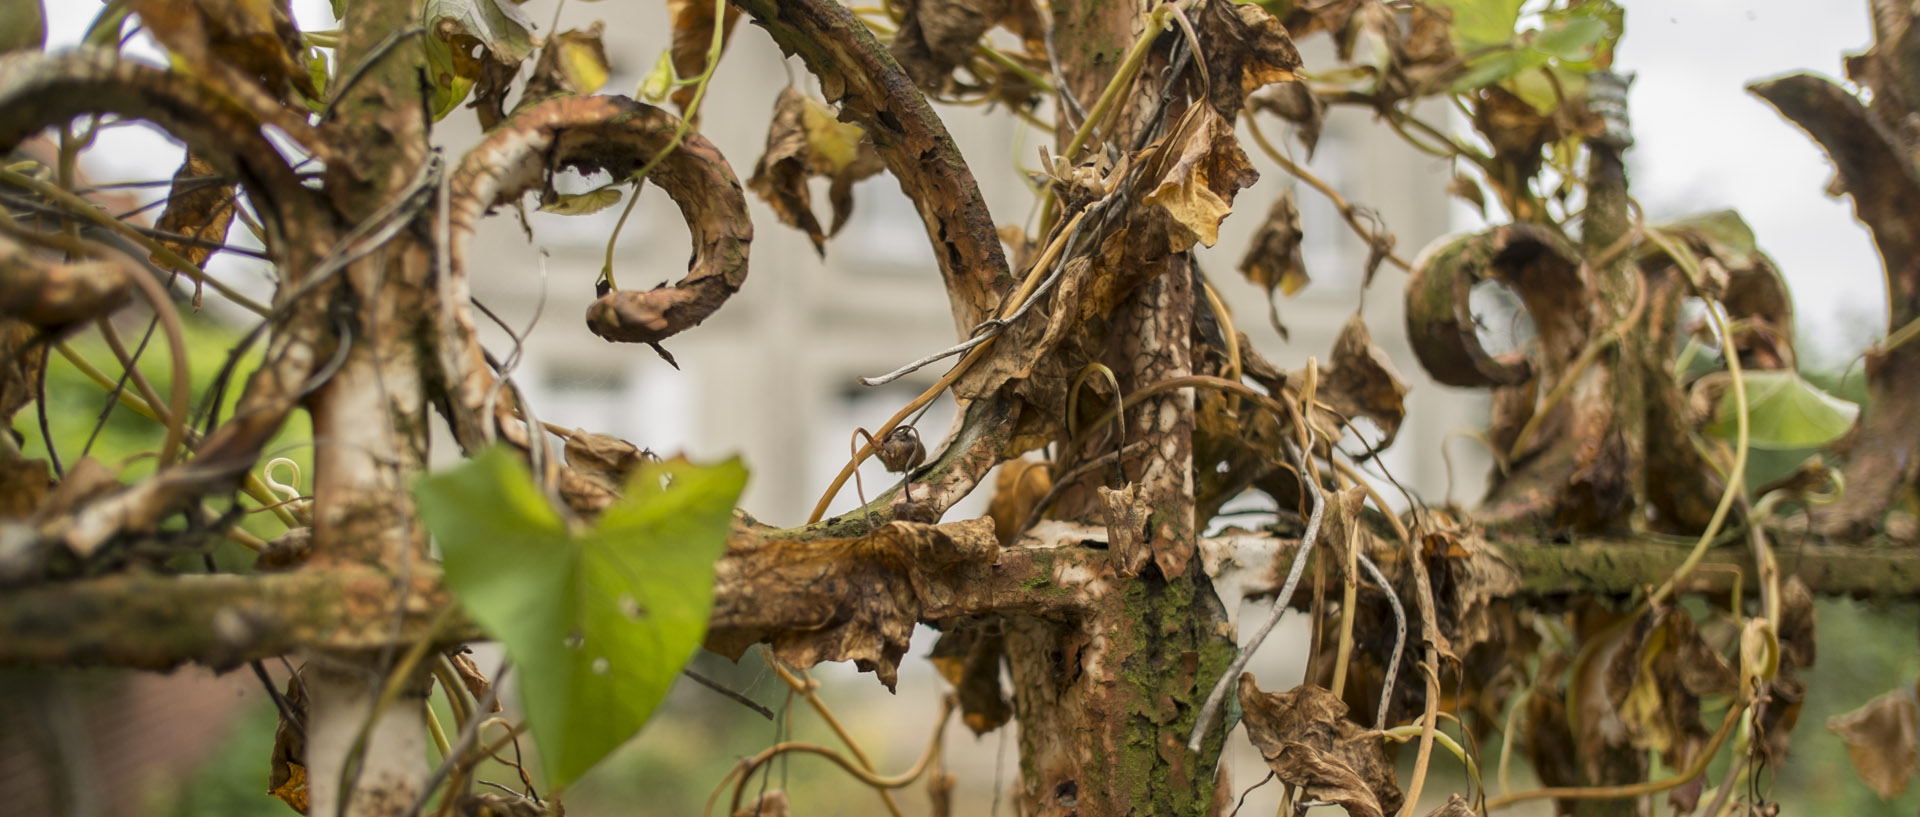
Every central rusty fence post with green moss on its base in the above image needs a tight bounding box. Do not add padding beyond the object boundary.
[1006,0,1235,817]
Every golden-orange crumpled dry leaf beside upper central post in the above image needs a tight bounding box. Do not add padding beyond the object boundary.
[1140,105,1260,253]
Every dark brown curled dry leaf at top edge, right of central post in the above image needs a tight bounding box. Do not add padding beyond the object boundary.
[1196,0,1300,119]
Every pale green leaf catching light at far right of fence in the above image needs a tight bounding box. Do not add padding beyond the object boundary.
[1707,368,1860,451]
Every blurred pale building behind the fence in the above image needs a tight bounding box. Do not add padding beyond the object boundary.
[453,4,1482,524]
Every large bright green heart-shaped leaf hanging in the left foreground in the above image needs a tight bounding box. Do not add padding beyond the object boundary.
[415,447,747,788]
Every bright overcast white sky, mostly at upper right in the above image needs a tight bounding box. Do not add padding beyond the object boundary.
[46,0,1885,366]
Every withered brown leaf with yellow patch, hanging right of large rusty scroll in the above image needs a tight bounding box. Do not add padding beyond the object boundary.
[747,86,885,255]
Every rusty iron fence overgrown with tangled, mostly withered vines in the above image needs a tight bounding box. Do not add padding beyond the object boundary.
[0,0,1920,817]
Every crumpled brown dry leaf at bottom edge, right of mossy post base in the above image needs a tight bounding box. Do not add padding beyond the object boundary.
[1240,673,1404,817]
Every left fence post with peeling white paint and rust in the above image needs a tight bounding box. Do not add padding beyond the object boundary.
[300,0,440,817]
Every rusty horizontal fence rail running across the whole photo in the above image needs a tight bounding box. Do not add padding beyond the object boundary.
[0,520,1920,681]
